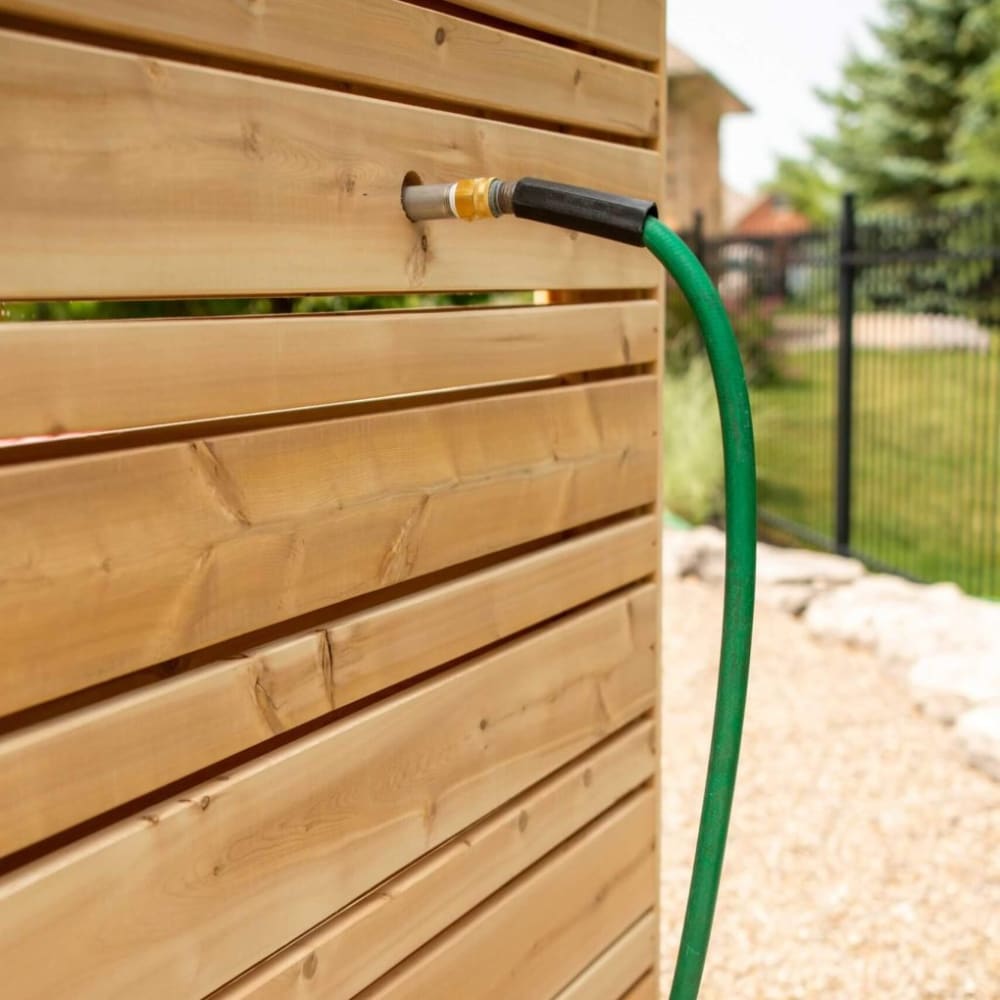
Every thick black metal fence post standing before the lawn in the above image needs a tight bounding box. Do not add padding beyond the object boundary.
[834,194,857,555]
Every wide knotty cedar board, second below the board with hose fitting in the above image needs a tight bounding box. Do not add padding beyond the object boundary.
[0,376,659,713]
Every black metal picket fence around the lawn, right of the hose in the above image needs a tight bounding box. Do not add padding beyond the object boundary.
[689,197,1000,597]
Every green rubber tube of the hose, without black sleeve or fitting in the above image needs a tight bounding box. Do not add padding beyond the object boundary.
[643,218,757,1000]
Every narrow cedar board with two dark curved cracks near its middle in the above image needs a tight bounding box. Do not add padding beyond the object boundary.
[0,517,658,855]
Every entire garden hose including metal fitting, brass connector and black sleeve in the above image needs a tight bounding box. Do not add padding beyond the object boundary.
[403,178,757,1000]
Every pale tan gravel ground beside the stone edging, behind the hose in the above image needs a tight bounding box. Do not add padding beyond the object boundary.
[663,580,1000,1000]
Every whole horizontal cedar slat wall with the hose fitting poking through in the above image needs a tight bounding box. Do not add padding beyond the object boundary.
[0,0,664,1000]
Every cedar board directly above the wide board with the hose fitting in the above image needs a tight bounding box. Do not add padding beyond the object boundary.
[0,0,660,136]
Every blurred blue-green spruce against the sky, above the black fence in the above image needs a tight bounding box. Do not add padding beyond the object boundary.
[813,0,997,209]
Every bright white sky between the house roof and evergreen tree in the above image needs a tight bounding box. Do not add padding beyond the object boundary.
[667,0,883,194]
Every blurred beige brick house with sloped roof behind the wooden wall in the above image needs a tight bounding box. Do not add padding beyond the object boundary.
[663,43,751,233]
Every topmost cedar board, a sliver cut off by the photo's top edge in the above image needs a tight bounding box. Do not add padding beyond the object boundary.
[461,0,663,61]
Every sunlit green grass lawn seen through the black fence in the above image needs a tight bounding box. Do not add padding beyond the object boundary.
[752,343,1000,597]
